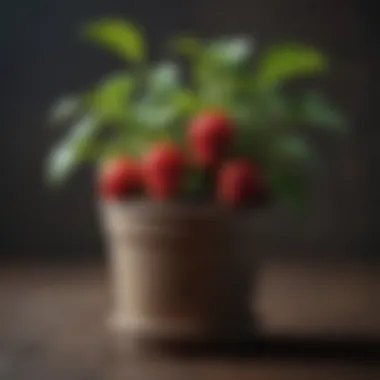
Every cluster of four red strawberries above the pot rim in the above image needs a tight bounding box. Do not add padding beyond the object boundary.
[99,109,268,207]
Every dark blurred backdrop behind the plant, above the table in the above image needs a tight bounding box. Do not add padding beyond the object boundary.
[0,0,380,258]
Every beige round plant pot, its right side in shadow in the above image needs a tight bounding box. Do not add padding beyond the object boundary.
[101,201,255,340]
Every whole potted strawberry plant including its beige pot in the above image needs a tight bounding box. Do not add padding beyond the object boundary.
[47,19,342,339]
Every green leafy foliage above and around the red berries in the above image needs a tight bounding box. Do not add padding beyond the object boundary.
[48,19,345,214]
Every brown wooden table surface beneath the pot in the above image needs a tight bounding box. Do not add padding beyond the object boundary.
[0,261,380,380]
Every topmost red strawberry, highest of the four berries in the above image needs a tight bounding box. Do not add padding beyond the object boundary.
[188,110,234,167]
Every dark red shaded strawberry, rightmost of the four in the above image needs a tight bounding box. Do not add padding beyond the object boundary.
[217,159,261,207]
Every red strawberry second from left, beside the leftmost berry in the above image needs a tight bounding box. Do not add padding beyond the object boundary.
[143,142,185,199]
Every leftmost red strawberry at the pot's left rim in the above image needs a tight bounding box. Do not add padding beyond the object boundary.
[99,157,141,198]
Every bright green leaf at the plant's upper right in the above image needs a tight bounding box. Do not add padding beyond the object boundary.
[256,43,327,89]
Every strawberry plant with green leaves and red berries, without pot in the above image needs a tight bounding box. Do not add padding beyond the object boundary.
[47,19,344,214]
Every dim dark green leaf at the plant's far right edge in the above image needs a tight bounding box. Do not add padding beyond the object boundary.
[301,92,347,132]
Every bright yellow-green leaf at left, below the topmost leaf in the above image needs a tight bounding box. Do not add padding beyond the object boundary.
[92,73,136,121]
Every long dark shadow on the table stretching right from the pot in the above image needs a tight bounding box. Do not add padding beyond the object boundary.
[142,337,380,365]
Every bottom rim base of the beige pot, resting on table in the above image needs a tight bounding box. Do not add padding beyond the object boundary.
[107,308,258,354]
